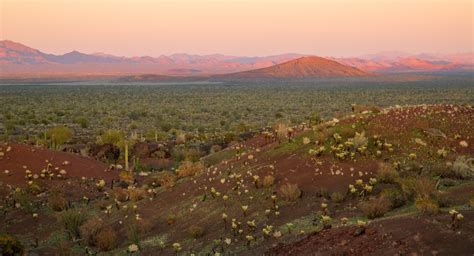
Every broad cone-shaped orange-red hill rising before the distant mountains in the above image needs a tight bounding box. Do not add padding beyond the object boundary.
[226,56,371,78]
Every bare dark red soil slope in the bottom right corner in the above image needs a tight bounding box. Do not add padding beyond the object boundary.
[267,210,474,255]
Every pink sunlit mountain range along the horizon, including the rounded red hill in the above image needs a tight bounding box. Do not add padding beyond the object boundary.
[0,40,474,77]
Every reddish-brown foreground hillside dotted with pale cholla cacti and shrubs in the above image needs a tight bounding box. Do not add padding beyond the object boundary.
[0,105,474,255]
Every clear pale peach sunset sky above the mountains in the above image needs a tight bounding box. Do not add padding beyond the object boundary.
[0,0,474,57]
